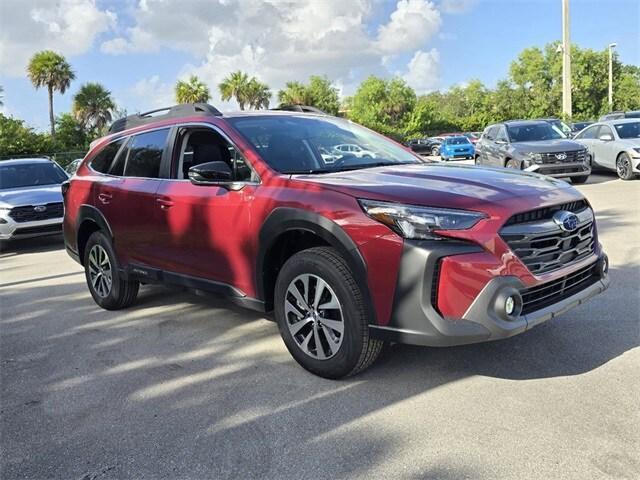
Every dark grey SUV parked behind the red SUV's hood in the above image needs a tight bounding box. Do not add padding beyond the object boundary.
[476,120,591,183]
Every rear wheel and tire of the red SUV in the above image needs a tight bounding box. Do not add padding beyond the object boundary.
[84,232,140,310]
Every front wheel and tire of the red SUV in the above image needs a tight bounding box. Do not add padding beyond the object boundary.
[274,247,383,379]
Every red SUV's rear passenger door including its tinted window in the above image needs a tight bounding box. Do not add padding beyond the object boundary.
[107,128,170,264]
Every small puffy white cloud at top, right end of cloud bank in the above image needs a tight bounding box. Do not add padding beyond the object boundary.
[377,0,441,53]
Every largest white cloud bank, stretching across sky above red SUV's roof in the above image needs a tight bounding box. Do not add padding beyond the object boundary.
[100,0,441,109]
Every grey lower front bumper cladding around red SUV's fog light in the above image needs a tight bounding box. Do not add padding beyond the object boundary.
[369,242,609,347]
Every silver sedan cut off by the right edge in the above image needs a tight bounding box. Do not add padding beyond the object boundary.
[574,118,640,180]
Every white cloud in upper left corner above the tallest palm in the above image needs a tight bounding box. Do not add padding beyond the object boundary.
[0,0,117,76]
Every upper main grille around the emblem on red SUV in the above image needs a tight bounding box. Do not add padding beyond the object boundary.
[500,202,595,275]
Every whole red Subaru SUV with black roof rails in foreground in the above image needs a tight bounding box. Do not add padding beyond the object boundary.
[64,104,609,378]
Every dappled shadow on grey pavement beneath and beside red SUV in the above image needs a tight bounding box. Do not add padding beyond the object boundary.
[0,256,639,478]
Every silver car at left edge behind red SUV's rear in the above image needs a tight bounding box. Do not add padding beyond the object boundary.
[0,158,69,241]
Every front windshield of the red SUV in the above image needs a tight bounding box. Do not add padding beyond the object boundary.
[228,115,421,173]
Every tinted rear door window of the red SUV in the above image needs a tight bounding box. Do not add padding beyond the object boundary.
[124,129,169,178]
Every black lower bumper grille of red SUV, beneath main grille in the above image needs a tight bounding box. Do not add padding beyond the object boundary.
[520,263,600,315]
